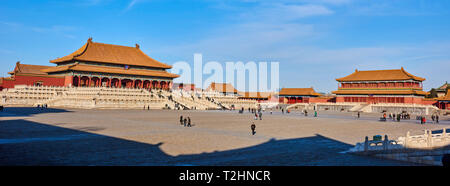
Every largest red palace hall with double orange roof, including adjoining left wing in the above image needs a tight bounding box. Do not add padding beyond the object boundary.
[0,38,179,89]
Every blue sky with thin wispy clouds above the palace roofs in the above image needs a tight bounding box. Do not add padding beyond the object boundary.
[0,0,450,92]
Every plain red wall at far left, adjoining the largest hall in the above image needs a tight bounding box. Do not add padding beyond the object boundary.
[1,75,65,88]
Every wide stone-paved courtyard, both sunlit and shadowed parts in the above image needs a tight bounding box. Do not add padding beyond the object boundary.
[0,108,450,166]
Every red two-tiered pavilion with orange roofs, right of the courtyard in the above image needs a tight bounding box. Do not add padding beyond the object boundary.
[333,67,427,104]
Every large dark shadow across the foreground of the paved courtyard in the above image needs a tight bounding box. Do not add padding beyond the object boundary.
[0,119,422,166]
